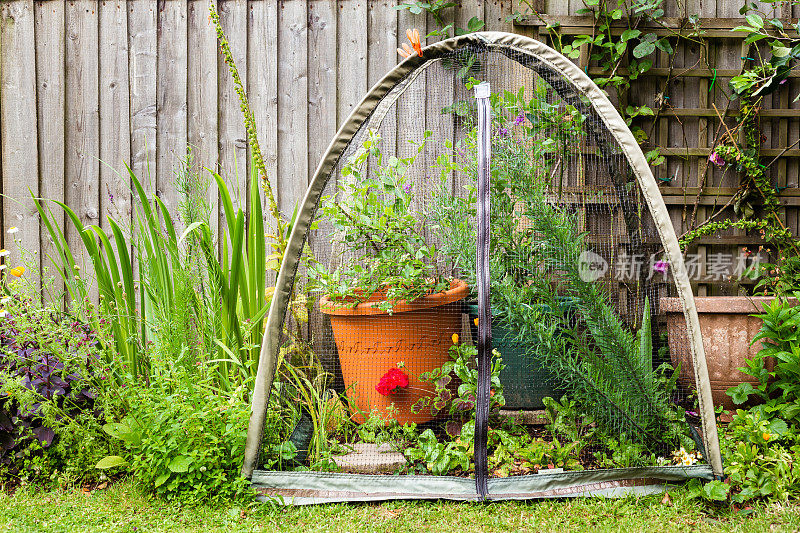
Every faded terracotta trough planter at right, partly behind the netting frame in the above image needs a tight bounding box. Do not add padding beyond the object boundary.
[661,296,774,410]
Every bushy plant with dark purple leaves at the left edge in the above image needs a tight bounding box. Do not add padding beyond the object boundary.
[0,277,120,486]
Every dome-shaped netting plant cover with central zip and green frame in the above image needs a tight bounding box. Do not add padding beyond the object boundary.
[244,34,716,503]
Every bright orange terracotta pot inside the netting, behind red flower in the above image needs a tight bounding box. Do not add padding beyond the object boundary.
[320,280,469,424]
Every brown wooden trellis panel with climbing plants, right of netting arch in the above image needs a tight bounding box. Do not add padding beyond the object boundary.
[515,2,800,294]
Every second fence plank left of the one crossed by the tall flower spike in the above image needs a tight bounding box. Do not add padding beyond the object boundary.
[156,0,188,218]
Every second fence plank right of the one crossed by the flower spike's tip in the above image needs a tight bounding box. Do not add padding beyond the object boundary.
[278,0,308,216]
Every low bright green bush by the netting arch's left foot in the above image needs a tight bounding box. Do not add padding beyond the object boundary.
[96,366,251,504]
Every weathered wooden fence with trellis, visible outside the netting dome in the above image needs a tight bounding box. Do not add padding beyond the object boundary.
[0,0,800,292]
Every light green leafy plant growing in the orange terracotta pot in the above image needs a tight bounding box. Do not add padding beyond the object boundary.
[309,131,450,311]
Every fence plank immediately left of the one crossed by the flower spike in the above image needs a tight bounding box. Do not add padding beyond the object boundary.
[186,0,219,235]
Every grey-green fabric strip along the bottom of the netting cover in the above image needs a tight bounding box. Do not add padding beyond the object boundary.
[252,465,714,505]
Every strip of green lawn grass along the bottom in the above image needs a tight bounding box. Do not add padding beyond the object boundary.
[0,481,800,533]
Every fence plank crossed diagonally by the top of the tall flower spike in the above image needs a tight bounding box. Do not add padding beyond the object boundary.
[217,0,248,228]
